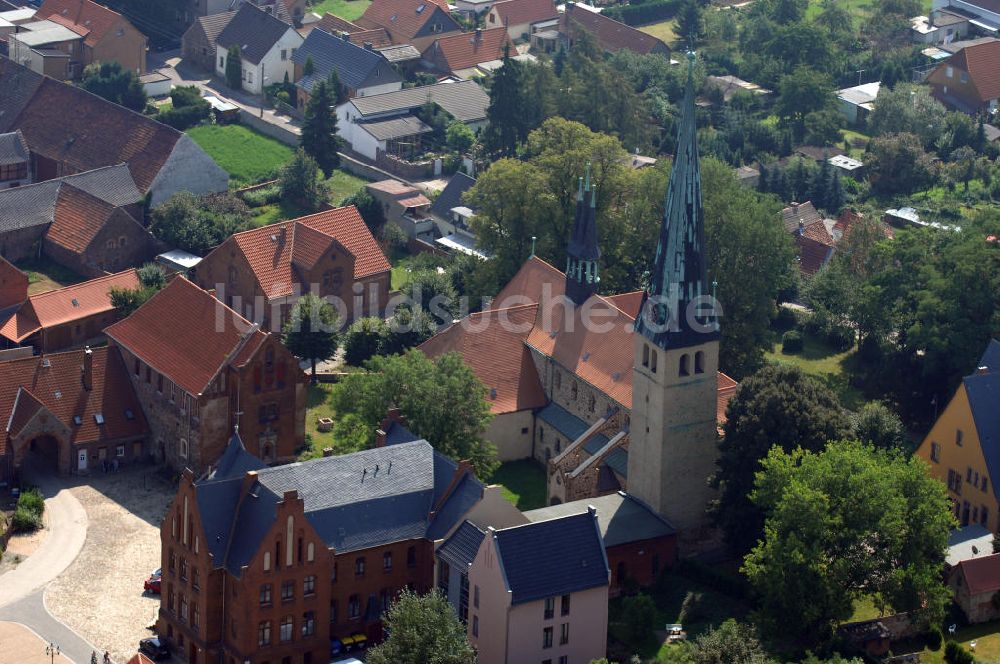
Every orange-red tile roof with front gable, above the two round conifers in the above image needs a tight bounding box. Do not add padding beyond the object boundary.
[224,205,392,298]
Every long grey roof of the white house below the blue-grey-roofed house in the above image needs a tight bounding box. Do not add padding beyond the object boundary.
[349,81,490,122]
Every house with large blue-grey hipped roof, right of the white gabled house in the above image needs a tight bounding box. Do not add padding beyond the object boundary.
[292,28,403,110]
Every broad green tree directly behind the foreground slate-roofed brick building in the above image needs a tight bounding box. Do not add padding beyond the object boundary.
[330,350,498,479]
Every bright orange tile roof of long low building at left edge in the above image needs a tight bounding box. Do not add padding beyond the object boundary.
[0,269,139,343]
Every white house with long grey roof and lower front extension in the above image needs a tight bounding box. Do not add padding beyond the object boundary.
[337,81,490,160]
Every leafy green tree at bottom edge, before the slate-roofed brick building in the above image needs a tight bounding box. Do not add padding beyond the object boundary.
[366,588,476,664]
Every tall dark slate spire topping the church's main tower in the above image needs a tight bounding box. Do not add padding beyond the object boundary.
[636,52,719,348]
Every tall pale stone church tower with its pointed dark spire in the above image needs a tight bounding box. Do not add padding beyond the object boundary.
[628,53,719,537]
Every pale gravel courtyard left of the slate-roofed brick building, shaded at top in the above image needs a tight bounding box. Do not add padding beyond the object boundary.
[45,466,176,662]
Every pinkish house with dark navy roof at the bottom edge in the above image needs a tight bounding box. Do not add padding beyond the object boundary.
[468,508,610,664]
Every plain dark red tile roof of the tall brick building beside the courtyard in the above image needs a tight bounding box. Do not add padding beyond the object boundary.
[105,276,266,396]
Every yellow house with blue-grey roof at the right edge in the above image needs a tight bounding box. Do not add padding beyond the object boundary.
[917,340,1000,533]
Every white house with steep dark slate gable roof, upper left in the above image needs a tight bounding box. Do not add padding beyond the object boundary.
[215,2,303,94]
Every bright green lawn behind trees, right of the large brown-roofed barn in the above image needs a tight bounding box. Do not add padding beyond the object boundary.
[187,124,293,188]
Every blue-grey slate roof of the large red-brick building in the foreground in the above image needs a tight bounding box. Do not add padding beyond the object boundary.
[196,440,483,575]
